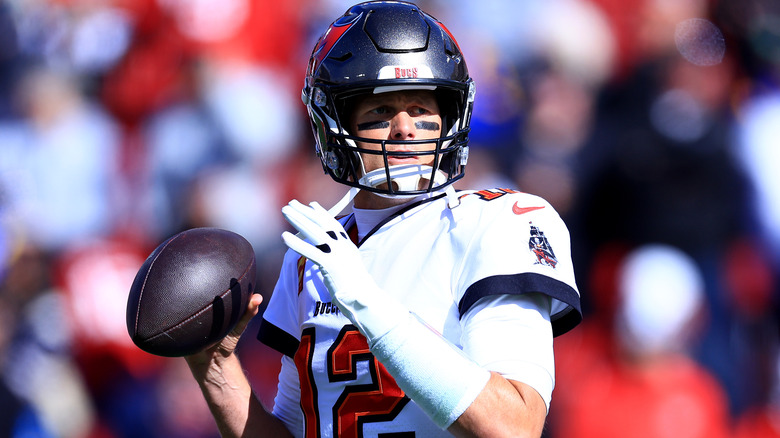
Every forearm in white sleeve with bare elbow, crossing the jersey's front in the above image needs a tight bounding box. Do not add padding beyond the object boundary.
[370,318,546,437]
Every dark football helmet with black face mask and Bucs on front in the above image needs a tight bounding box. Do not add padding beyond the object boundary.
[302,1,475,196]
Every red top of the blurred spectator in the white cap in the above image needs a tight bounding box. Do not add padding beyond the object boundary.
[554,356,730,438]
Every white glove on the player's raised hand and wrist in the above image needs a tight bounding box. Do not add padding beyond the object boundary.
[282,200,409,345]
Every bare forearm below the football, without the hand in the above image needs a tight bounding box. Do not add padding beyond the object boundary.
[187,354,290,437]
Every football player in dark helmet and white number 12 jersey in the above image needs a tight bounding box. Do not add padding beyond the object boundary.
[187,1,581,437]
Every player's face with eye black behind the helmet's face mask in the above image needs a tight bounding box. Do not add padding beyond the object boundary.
[350,90,442,173]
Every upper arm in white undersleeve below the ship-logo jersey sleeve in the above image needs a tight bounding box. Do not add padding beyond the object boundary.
[449,293,555,437]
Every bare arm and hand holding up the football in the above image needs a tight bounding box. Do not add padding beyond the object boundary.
[185,294,292,437]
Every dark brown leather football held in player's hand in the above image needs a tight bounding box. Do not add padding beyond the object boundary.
[127,228,256,357]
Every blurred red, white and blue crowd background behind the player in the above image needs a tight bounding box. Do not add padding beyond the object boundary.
[0,0,780,438]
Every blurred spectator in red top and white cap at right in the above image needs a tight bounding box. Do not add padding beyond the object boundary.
[550,245,731,438]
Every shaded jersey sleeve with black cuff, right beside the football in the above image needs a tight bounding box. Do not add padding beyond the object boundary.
[257,250,305,357]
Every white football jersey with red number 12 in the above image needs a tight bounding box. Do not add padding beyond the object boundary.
[258,189,581,437]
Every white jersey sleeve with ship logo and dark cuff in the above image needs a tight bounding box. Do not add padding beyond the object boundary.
[458,193,582,336]
